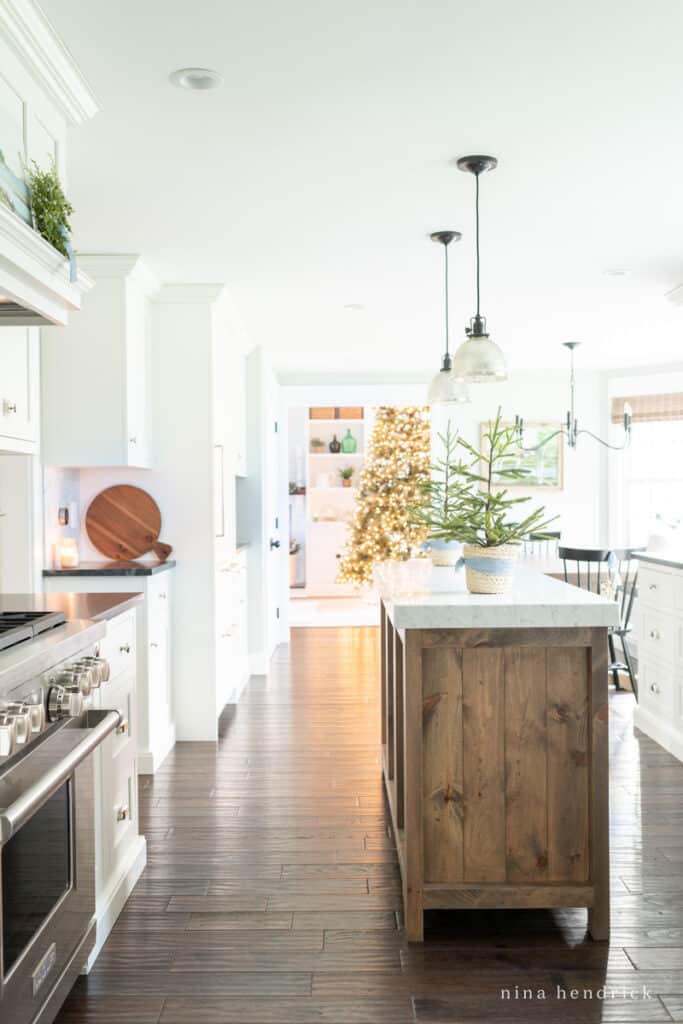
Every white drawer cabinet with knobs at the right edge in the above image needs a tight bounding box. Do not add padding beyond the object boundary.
[634,561,683,761]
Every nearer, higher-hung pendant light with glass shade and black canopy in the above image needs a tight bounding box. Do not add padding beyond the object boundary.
[453,157,508,384]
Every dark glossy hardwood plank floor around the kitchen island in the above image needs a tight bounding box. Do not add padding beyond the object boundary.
[57,629,683,1024]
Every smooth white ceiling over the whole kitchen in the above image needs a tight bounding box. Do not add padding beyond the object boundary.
[42,0,683,375]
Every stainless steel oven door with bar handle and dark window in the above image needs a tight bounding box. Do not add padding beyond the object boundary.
[0,712,119,1024]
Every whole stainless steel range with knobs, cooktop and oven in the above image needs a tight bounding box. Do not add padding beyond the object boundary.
[0,612,121,1024]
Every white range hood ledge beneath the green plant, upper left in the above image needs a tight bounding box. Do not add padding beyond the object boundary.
[0,201,93,327]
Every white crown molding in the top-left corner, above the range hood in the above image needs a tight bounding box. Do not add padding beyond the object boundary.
[0,0,99,125]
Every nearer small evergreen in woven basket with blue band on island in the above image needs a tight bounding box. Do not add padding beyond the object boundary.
[413,409,557,594]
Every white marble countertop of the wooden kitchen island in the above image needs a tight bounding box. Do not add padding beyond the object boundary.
[384,566,618,630]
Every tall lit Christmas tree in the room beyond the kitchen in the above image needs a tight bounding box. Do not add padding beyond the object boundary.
[338,406,430,587]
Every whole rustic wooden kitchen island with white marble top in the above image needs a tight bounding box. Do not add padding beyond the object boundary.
[381,569,617,942]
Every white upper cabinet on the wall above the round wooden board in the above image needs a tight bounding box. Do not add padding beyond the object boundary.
[42,254,157,467]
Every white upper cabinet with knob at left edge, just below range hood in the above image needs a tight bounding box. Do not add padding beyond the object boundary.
[0,327,40,454]
